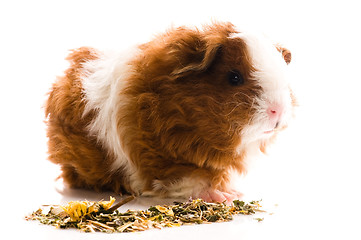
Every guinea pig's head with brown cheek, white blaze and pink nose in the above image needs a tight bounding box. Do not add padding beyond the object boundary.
[132,23,295,168]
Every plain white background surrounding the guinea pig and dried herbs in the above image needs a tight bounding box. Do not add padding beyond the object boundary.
[0,0,361,239]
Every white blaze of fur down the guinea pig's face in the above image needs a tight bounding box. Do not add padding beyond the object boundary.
[231,32,292,145]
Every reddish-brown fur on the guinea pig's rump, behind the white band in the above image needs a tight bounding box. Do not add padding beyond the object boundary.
[46,47,126,193]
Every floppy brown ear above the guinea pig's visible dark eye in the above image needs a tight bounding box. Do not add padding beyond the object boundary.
[172,40,222,75]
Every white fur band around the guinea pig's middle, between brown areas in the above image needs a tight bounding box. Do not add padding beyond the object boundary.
[82,47,136,175]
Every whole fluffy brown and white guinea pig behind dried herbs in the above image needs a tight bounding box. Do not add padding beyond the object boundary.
[46,23,295,201]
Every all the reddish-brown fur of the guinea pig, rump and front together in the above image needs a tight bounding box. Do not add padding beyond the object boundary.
[46,24,292,198]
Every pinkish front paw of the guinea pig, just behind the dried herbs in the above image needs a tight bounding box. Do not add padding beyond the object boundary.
[196,189,243,203]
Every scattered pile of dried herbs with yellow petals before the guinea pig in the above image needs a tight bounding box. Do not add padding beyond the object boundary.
[26,197,263,233]
